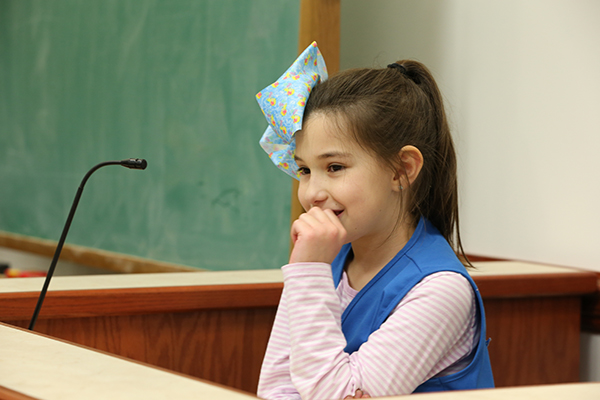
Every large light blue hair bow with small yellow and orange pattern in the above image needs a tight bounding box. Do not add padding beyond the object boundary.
[256,42,327,179]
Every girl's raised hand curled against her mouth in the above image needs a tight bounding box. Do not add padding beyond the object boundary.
[290,207,346,264]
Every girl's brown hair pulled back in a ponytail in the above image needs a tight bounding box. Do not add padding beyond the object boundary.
[304,60,470,264]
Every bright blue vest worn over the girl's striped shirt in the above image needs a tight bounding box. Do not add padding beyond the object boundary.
[331,218,494,392]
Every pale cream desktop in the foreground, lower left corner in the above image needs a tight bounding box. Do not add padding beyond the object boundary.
[0,324,256,400]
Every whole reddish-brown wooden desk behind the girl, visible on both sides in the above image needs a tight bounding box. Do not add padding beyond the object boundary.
[0,262,597,393]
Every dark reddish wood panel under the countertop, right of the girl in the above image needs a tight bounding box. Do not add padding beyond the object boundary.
[484,296,581,387]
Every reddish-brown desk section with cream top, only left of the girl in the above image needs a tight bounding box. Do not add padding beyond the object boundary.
[0,270,282,393]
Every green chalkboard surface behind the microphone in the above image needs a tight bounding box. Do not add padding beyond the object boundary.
[0,0,299,270]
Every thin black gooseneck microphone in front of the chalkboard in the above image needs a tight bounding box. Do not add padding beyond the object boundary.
[29,158,148,331]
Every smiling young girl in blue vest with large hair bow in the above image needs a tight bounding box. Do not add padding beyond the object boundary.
[258,44,493,399]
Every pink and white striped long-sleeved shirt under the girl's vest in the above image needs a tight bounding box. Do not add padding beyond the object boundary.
[258,263,479,399]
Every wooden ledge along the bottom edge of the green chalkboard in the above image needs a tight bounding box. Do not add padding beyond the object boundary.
[0,231,196,273]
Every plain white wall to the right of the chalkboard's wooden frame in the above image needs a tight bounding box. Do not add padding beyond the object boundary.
[341,0,600,380]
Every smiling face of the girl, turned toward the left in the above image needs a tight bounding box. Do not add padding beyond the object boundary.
[296,114,400,245]
